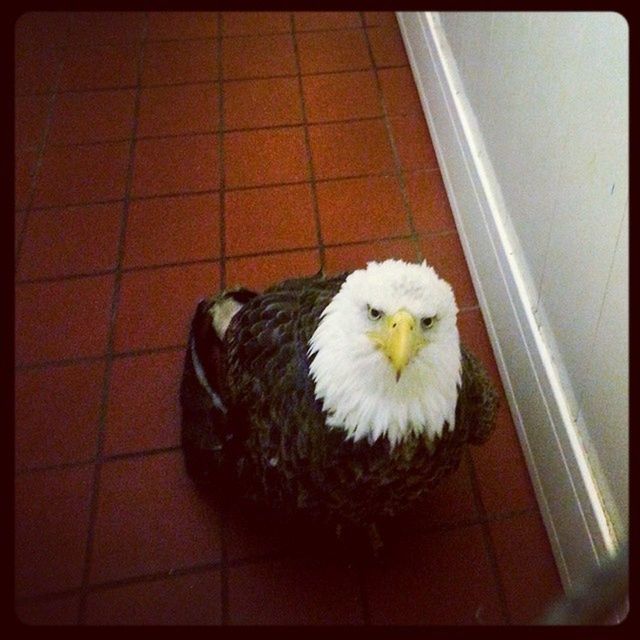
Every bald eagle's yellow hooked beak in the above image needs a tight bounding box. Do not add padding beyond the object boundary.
[367,309,426,382]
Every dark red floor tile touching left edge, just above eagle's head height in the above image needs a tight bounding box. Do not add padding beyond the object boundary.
[18,203,122,278]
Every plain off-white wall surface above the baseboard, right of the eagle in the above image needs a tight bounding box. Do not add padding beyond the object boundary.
[440,12,629,528]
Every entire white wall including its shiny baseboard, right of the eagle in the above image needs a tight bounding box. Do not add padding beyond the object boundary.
[398,12,628,585]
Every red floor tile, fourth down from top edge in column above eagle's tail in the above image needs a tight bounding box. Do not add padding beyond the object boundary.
[132,134,220,196]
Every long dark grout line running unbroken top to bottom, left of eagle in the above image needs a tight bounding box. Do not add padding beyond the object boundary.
[78,13,148,624]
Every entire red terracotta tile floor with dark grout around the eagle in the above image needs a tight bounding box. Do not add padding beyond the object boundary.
[15,12,561,625]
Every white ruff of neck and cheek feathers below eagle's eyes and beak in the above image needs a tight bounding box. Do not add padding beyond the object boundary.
[309,278,460,445]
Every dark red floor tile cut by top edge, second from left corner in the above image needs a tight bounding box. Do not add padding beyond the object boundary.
[66,11,144,46]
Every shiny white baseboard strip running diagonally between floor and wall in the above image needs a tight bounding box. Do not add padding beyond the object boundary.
[397,12,617,589]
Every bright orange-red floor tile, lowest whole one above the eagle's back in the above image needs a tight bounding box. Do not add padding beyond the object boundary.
[225,184,317,256]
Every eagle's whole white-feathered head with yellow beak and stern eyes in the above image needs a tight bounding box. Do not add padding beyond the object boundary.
[309,260,461,445]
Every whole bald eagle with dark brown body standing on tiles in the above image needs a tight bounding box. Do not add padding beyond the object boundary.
[180,260,497,551]
